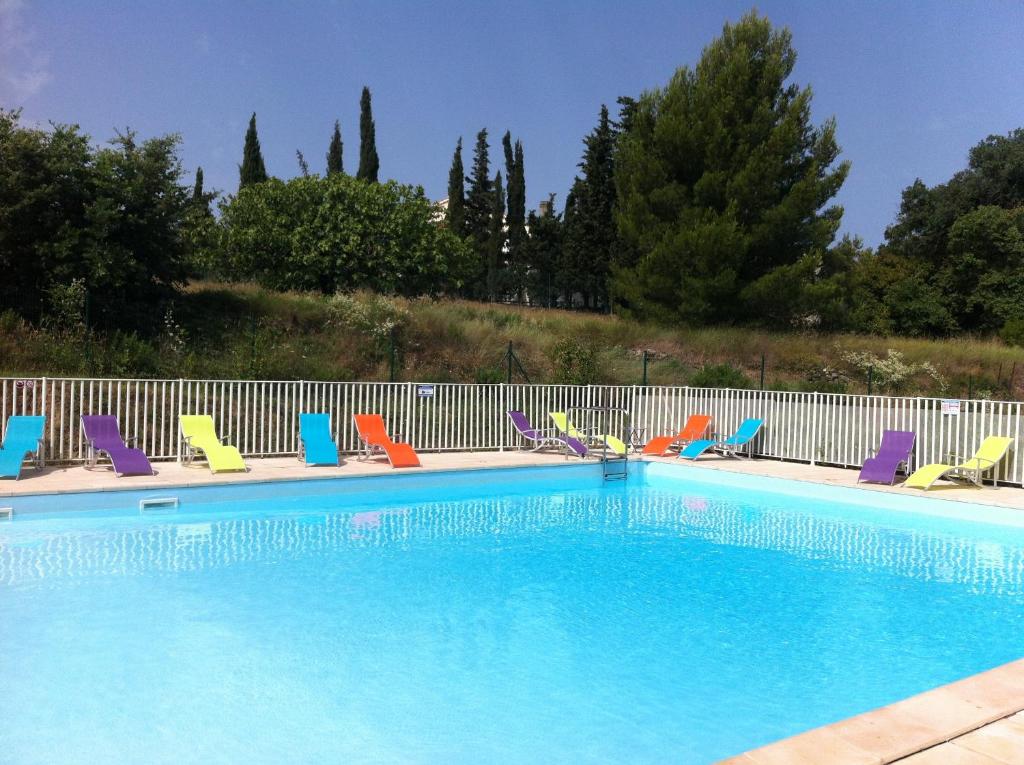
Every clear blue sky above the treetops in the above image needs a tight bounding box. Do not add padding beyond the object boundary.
[0,0,1024,245]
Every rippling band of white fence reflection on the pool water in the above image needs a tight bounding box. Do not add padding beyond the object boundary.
[0,491,1024,594]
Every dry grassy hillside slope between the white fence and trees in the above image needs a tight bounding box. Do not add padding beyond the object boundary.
[0,283,1024,398]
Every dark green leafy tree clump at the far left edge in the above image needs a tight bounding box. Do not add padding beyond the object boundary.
[0,110,190,331]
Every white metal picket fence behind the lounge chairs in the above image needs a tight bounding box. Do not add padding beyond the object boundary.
[0,378,1024,484]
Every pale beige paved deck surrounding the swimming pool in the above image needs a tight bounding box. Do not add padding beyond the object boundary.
[6,451,1024,765]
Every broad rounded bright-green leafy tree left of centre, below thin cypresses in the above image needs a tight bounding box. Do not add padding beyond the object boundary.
[221,173,469,295]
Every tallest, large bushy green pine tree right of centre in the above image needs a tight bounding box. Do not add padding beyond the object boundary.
[614,12,849,324]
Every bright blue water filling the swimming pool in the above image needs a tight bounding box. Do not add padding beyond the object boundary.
[0,465,1024,763]
